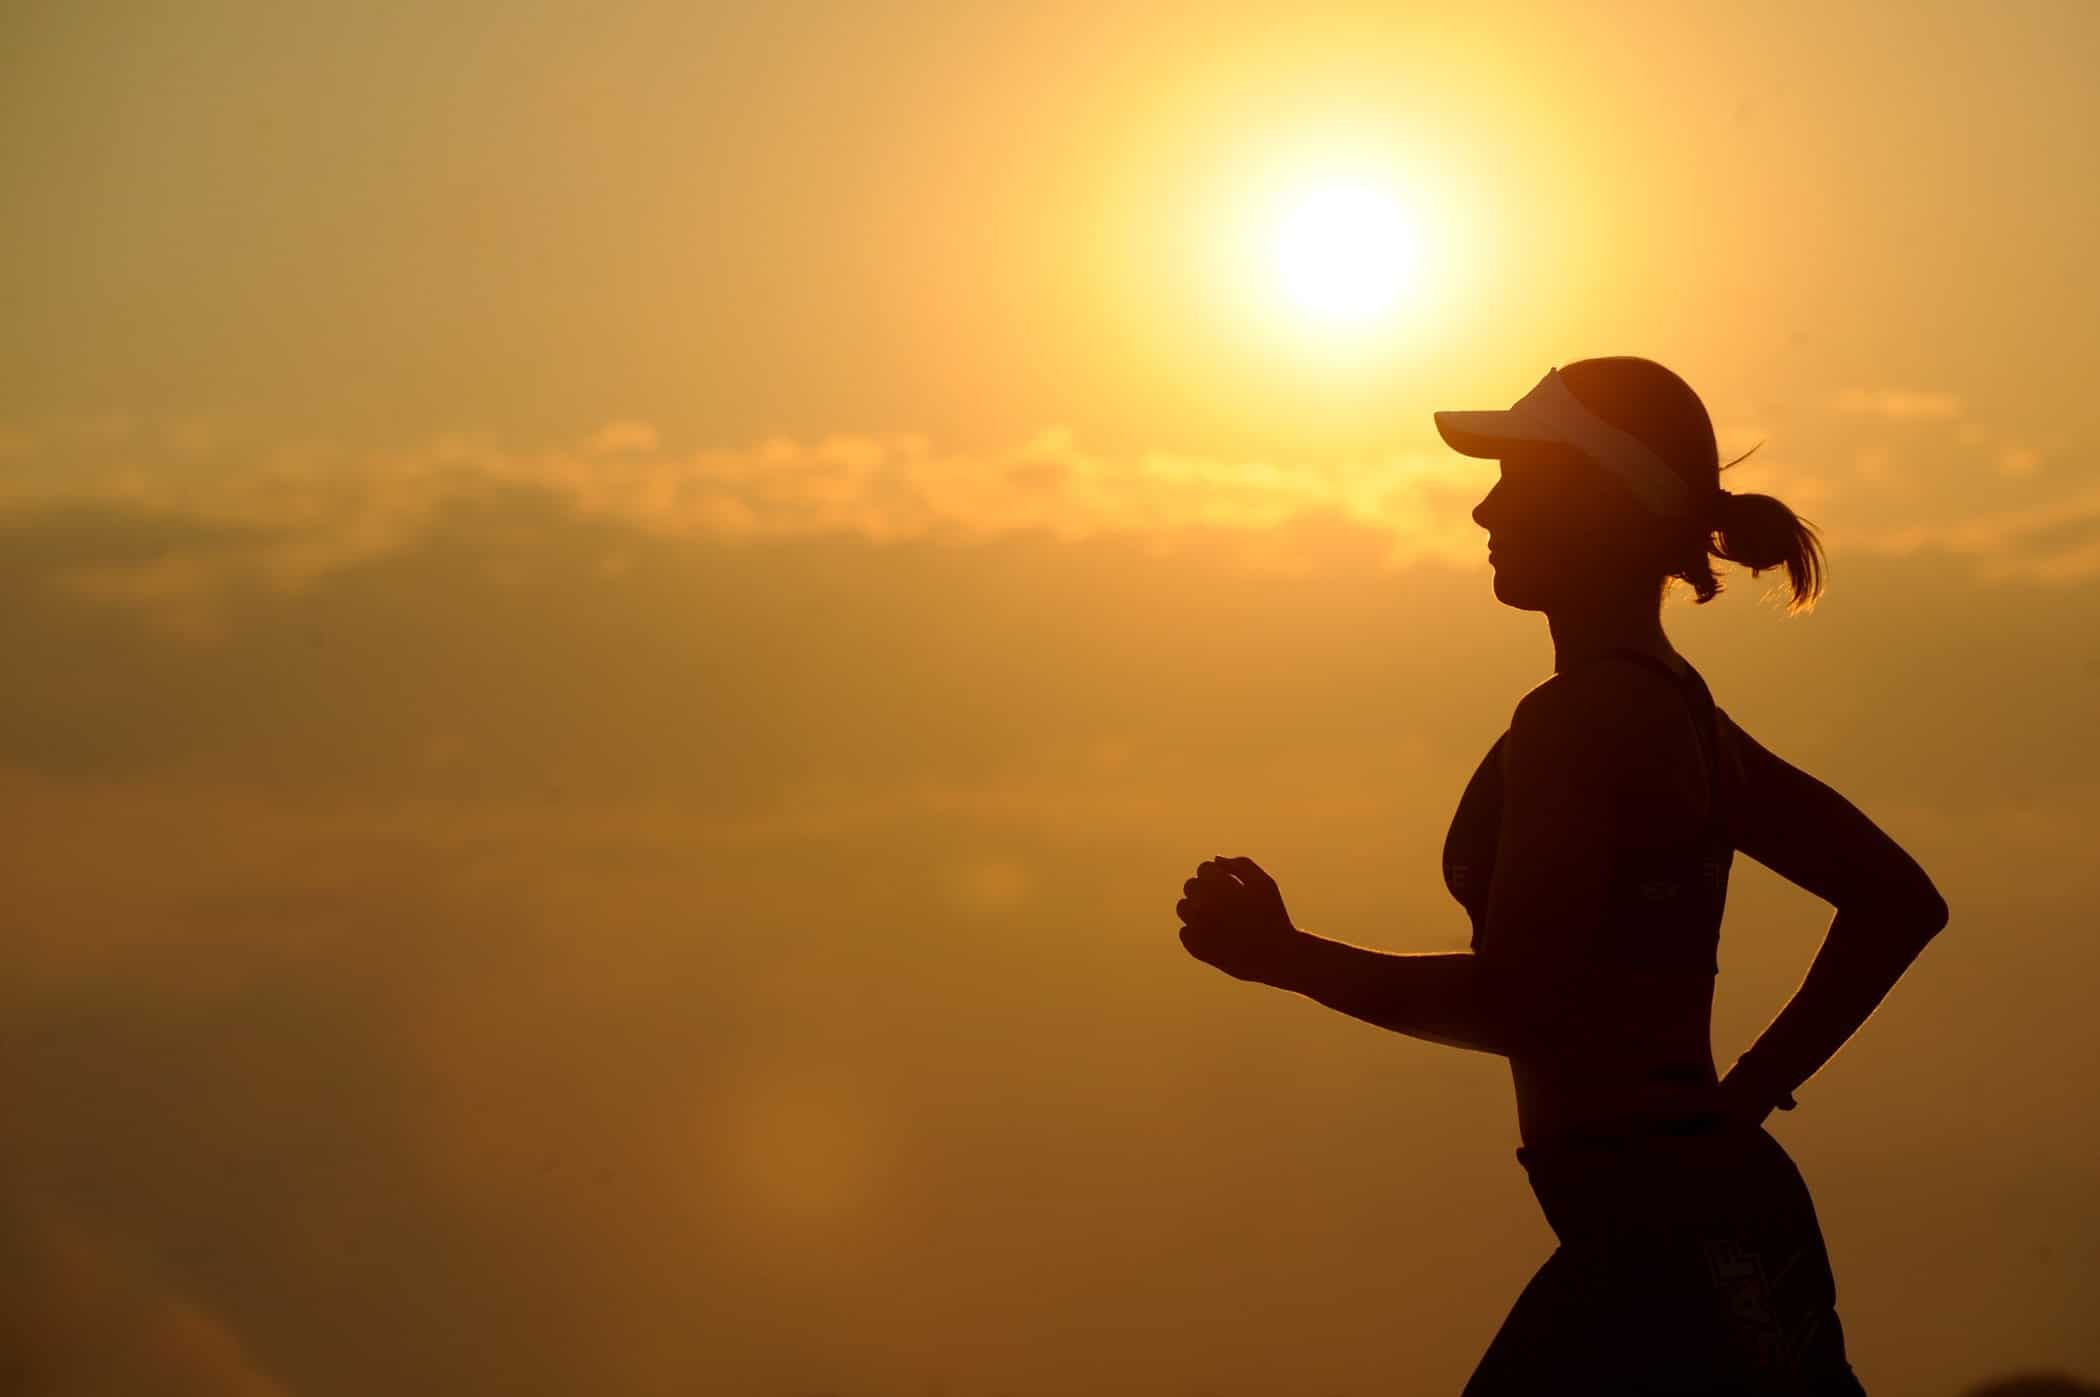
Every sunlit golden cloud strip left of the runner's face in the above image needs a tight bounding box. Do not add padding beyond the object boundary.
[0,422,1489,645]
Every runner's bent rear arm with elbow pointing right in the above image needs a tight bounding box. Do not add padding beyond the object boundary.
[1728,721,1947,1101]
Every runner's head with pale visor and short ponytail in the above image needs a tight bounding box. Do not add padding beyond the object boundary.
[1436,355,1823,611]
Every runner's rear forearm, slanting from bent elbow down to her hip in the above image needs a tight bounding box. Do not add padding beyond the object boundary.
[1728,905,1947,1101]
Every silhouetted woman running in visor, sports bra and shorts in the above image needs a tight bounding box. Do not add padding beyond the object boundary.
[1176,355,1947,1397]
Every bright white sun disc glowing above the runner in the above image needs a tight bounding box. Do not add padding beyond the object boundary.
[1275,183,1418,326]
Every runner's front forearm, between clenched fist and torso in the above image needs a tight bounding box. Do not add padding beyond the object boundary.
[1264,931,1504,1055]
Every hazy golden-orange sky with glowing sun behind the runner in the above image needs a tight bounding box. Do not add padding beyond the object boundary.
[0,0,2100,1397]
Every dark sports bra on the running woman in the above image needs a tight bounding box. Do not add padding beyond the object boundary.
[1443,649,1735,975]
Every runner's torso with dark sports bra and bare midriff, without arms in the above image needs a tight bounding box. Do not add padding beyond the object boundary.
[1445,653,1733,1145]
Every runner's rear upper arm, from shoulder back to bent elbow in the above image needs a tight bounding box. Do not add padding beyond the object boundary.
[1724,718,1947,920]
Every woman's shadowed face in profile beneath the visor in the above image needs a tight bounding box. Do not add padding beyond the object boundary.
[1472,443,1646,611]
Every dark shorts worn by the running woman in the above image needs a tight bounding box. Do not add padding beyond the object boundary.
[1464,1118,1865,1397]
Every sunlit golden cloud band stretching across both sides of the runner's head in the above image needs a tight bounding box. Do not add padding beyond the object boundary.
[0,409,2092,649]
